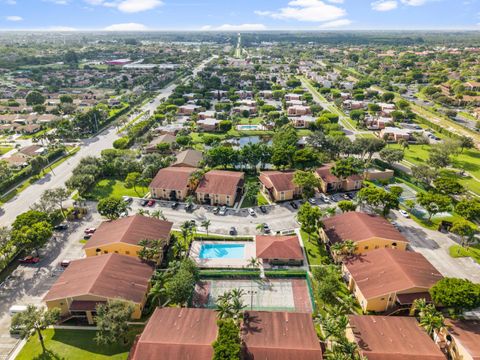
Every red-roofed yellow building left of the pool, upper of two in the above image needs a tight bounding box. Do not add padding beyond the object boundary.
[83,215,173,262]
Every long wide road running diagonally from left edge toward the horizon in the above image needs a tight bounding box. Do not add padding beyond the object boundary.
[0,57,213,226]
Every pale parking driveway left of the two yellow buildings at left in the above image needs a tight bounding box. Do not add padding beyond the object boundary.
[0,204,102,359]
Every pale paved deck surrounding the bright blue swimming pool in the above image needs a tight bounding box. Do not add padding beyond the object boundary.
[190,241,256,268]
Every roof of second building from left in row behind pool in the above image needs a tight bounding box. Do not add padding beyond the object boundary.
[197,170,244,196]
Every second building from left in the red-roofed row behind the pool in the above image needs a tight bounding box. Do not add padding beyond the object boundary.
[196,170,245,206]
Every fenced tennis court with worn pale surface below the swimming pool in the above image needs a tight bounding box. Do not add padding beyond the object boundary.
[193,279,312,312]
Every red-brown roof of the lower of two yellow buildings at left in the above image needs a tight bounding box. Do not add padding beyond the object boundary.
[43,254,153,303]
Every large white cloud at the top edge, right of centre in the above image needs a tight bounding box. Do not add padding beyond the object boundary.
[255,0,347,22]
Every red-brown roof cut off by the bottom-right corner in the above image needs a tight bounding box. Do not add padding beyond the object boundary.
[446,319,480,360]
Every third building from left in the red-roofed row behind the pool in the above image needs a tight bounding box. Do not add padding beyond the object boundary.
[258,171,302,201]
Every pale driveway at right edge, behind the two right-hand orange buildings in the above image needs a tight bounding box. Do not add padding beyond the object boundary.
[391,211,480,283]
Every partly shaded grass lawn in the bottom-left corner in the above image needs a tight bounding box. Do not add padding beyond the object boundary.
[16,327,141,360]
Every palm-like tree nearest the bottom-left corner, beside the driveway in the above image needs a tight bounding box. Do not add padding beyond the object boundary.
[11,305,60,354]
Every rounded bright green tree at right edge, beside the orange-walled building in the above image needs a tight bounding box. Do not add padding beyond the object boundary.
[430,278,480,312]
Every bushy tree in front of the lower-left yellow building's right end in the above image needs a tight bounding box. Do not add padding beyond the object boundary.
[95,299,135,345]
